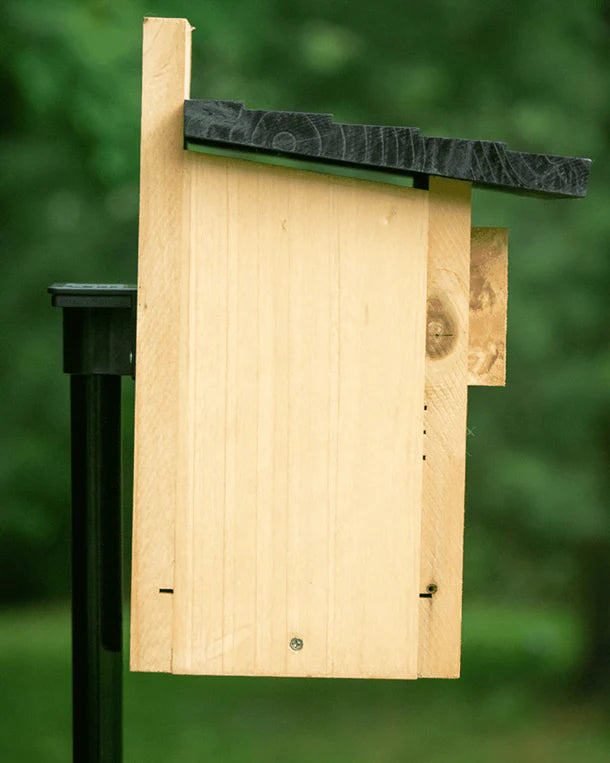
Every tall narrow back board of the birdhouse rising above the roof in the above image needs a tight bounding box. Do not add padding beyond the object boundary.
[131,18,191,671]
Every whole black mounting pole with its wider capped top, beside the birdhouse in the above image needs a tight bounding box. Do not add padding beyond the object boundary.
[49,284,136,763]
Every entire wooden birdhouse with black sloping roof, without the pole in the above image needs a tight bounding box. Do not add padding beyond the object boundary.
[131,19,589,678]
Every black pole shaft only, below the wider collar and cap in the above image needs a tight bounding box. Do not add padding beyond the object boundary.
[70,374,122,763]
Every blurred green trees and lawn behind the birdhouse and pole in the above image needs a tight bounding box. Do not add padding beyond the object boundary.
[0,0,610,761]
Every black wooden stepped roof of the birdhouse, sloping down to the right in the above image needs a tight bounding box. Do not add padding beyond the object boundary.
[184,100,591,197]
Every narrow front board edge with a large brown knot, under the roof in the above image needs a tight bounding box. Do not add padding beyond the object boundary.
[418,177,470,678]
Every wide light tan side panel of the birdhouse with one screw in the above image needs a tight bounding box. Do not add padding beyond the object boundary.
[166,160,427,678]
